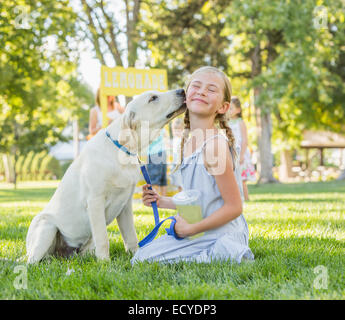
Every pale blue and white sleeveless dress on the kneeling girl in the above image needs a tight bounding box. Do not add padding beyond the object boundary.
[131,134,254,264]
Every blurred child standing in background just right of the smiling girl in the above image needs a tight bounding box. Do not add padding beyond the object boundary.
[228,97,256,201]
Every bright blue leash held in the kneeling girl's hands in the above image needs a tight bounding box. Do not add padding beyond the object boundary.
[138,165,183,248]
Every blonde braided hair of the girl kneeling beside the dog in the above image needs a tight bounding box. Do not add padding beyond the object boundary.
[174,66,236,171]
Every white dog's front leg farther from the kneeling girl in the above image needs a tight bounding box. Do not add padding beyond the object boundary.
[87,196,109,259]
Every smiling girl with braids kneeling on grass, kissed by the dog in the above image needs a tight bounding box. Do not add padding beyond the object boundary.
[132,67,254,263]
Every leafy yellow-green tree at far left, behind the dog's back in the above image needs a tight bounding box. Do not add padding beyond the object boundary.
[0,0,92,183]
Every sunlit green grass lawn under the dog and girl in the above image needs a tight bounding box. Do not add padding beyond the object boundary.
[0,182,345,299]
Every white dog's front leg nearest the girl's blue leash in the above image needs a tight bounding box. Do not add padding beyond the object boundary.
[116,199,138,253]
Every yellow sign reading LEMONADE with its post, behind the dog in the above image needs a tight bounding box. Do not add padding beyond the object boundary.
[100,66,168,127]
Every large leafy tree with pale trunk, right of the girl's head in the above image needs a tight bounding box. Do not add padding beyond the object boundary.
[224,0,344,182]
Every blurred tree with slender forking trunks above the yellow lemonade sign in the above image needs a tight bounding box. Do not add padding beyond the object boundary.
[79,0,143,101]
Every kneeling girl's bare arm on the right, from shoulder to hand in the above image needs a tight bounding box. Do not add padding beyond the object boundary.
[175,138,242,237]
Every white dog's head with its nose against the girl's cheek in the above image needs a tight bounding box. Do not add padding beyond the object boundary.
[119,89,186,149]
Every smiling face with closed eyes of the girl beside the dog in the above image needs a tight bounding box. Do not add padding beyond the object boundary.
[186,72,229,116]
